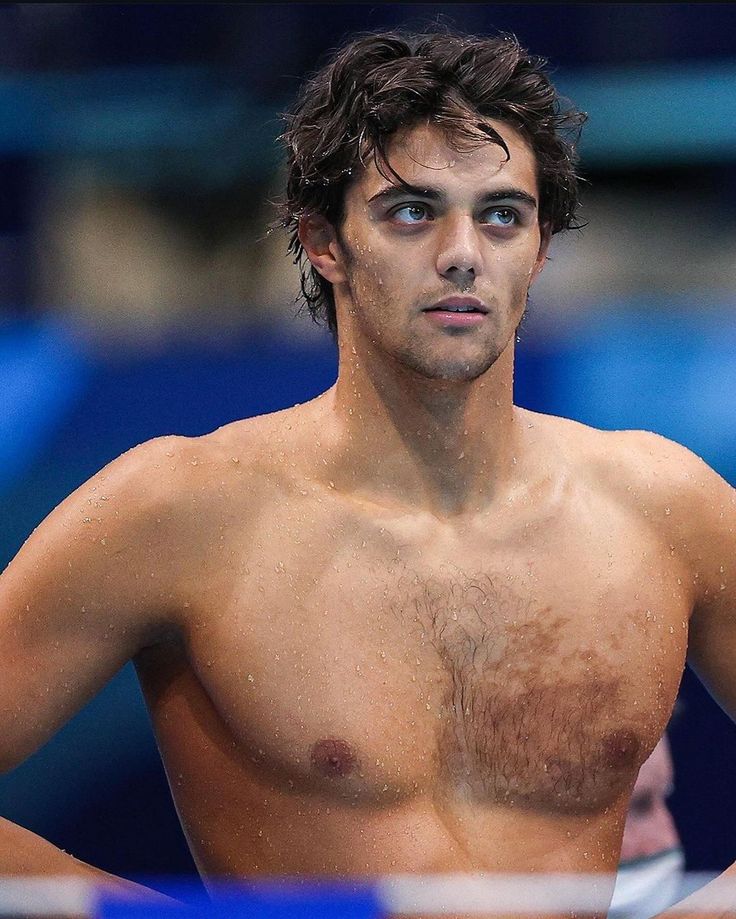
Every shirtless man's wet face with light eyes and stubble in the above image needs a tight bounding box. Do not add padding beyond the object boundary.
[307,121,547,381]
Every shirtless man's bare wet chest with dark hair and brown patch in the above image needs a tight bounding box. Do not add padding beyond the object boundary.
[184,528,687,813]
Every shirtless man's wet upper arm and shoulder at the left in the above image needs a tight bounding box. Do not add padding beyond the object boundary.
[0,441,187,769]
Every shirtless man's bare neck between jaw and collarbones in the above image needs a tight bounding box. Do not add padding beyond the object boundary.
[314,344,520,518]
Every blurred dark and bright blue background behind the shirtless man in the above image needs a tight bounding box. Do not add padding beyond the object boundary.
[0,3,736,892]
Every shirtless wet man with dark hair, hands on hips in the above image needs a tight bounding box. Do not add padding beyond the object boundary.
[0,25,736,916]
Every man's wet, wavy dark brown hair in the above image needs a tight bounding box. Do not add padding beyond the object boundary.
[279,30,586,336]
